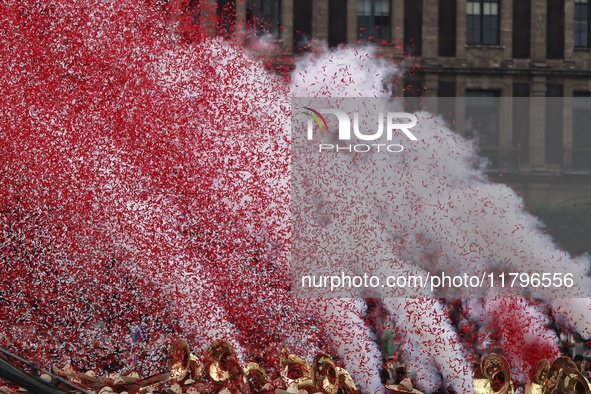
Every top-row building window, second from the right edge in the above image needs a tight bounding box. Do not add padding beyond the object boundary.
[466,0,499,45]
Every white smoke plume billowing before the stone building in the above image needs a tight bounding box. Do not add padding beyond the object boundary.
[292,43,591,392]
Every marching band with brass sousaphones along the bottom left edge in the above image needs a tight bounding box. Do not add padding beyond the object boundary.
[0,338,359,394]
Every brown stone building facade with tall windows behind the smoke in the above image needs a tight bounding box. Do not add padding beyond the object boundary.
[207,0,591,206]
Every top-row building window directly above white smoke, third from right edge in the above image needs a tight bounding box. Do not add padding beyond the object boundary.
[357,0,392,42]
